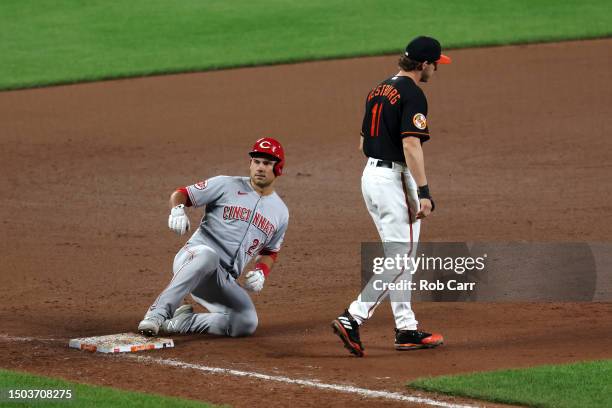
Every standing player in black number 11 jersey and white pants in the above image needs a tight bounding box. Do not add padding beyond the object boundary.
[332,37,451,357]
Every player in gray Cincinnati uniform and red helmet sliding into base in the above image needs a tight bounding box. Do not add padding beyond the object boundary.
[138,138,289,337]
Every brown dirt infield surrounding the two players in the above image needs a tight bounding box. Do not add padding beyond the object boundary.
[0,39,612,406]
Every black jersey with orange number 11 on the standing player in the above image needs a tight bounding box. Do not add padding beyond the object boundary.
[361,76,429,163]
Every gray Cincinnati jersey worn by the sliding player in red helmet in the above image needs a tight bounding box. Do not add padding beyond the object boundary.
[186,176,289,278]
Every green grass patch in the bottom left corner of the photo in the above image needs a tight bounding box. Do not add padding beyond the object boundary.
[0,369,219,408]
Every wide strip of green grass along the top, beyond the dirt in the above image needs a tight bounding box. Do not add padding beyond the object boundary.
[0,0,612,89]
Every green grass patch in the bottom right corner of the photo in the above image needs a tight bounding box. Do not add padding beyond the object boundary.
[409,360,612,408]
